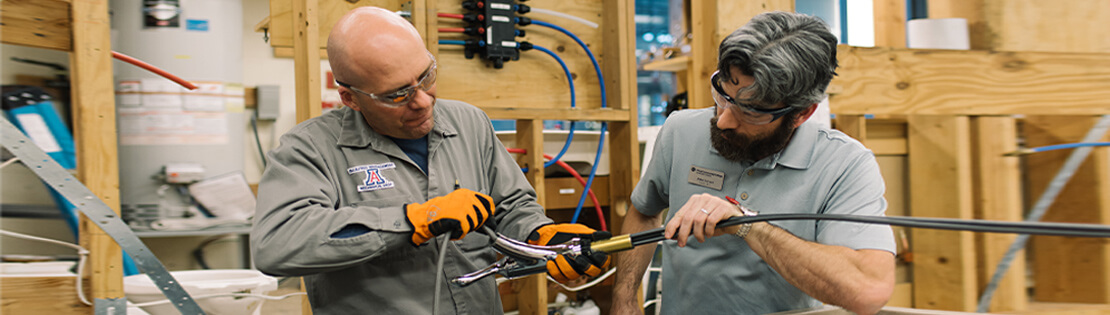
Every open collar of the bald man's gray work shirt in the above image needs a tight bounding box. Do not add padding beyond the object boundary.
[337,101,458,148]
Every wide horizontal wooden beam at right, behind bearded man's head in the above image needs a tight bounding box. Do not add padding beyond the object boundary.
[829,45,1110,115]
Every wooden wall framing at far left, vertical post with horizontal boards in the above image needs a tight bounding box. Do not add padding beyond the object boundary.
[0,0,123,314]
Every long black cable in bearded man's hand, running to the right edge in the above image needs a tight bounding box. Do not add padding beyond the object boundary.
[629,213,1110,246]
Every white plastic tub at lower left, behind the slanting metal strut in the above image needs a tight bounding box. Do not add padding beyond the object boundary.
[123,270,278,315]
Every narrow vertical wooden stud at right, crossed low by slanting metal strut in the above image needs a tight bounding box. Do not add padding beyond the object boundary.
[971,116,1029,312]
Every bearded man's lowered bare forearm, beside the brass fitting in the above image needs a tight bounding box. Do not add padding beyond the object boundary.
[613,209,659,309]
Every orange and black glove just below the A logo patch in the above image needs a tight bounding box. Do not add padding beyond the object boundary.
[404,189,494,246]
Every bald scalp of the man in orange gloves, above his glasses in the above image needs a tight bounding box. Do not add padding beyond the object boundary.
[327,7,426,89]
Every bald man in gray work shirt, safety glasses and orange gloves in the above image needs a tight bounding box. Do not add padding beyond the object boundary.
[251,7,608,315]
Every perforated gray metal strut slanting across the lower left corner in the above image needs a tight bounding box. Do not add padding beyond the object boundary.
[0,119,204,314]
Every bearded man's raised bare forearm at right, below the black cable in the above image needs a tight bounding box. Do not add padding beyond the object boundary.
[745,223,894,314]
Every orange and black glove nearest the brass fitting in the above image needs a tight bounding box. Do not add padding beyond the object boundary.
[528,224,612,283]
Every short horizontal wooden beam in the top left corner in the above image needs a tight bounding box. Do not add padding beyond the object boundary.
[0,0,73,51]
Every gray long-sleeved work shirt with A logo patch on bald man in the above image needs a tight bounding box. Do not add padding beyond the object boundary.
[251,100,552,315]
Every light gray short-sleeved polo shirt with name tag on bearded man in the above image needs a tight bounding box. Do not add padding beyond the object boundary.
[632,108,895,314]
